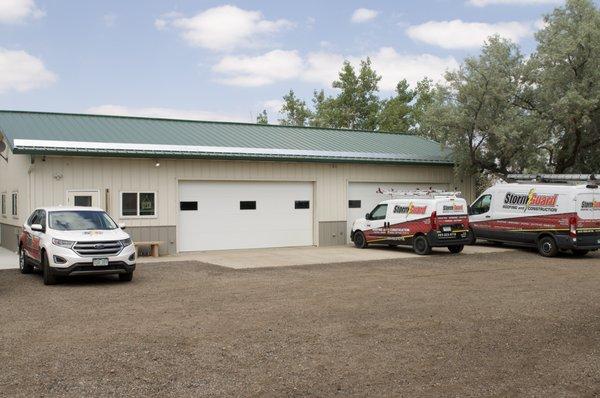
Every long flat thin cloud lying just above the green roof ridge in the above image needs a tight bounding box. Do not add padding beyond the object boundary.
[86,104,248,122]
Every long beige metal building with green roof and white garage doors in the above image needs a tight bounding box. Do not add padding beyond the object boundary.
[0,111,472,254]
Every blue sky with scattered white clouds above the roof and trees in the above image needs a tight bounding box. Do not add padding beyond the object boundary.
[0,0,572,121]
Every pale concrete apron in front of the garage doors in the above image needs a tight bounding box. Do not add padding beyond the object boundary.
[138,245,511,269]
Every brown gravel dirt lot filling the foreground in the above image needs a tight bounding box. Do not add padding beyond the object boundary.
[0,250,600,396]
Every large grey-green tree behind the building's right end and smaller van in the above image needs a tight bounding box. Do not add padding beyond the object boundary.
[418,37,543,175]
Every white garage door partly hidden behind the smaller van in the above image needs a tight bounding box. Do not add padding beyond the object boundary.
[346,182,448,242]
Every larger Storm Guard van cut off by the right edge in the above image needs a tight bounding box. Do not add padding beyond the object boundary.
[469,174,600,257]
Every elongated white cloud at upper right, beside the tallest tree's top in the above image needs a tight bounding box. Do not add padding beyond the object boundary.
[406,19,533,49]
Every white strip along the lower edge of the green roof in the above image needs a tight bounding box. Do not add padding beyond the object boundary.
[13,139,453,165]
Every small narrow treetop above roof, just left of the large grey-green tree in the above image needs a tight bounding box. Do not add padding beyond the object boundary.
[378,79,417,133]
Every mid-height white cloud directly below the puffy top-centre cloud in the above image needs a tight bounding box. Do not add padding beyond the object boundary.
[213,50,303,87]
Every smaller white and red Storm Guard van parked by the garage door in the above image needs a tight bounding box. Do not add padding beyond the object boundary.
[350,190,471,254]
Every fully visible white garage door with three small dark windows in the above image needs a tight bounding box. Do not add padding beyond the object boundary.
[178,181,314,251]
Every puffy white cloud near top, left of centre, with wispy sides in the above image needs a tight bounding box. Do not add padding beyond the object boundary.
[154,5,294,51]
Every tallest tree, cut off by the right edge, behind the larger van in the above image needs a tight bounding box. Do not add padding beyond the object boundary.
[520,0,600,173]
